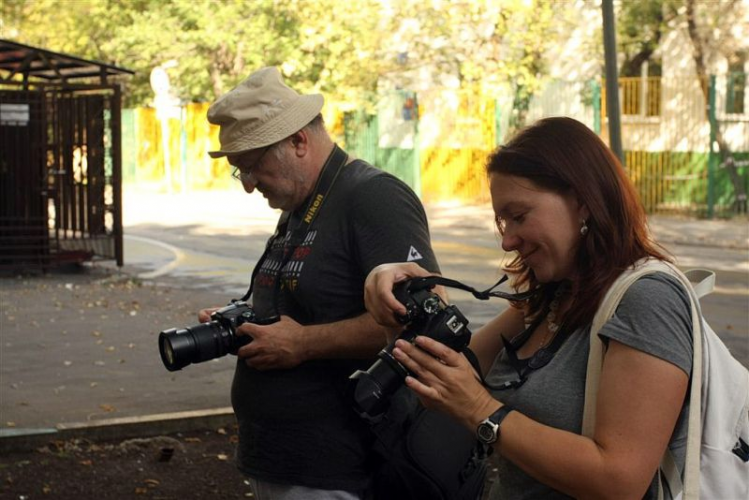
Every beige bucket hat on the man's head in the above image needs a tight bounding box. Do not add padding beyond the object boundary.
[208,67,324,158]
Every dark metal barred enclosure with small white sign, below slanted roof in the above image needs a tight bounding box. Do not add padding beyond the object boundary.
[0,84,123,269]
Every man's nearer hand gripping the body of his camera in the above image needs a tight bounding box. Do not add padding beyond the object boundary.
[237,316,308,370]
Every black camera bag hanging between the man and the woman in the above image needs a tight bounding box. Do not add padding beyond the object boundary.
[372,386,487,500]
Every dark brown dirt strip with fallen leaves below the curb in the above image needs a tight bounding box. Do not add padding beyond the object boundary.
[0,428,252,500]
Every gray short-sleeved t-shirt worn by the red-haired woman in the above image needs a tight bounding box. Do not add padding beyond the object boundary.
[487,273,692,500]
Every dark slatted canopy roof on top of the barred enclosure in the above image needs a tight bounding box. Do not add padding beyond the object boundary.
[0,39,135,84]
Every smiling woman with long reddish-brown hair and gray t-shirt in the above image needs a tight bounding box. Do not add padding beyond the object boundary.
[365,118,692,499]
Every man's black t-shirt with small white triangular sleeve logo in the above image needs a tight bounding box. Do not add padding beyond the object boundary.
[232,160,439,491]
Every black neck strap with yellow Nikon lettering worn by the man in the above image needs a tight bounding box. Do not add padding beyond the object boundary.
[241,144,348,302]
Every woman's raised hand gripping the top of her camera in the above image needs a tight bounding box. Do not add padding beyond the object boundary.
[364,262,438,326]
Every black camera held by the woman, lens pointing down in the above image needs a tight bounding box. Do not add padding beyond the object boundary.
[349,278,471,418]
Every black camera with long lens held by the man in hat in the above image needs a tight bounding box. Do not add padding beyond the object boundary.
[159,301,278,372]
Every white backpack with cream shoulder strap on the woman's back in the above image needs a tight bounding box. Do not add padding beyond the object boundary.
[583,259,749,500]
